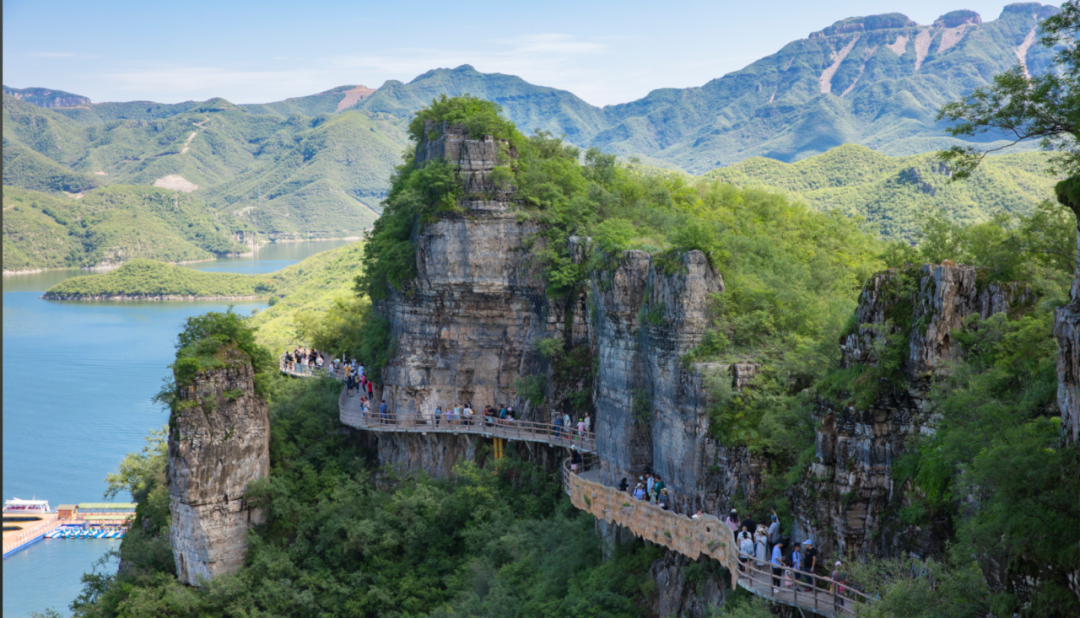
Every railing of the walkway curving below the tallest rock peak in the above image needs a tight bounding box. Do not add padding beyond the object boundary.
[338,390,596,453]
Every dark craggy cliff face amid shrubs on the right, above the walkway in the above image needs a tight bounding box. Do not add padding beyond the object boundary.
[793,264,1027,554]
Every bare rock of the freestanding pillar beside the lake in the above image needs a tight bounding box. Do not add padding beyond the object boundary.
[167,349,270,585]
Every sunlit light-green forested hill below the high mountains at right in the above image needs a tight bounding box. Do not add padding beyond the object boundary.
[705,144,1059,240]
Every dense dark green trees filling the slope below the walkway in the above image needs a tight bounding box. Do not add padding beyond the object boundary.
[73,367,657,618]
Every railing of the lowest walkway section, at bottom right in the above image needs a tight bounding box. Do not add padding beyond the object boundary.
[739,551,869,615]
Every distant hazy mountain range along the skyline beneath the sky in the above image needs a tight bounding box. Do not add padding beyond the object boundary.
[3,3,1057,248]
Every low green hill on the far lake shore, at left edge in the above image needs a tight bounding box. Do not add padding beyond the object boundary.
[3,183,252,270]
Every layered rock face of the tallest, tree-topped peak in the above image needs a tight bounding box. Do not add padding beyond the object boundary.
[379,125,551,430]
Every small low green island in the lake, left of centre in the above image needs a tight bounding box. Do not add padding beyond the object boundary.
[42,258,278,300]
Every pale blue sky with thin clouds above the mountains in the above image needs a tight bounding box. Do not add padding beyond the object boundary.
[3,0,1041,105]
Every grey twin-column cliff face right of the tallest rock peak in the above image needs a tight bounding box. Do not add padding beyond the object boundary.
[591,251,724,509]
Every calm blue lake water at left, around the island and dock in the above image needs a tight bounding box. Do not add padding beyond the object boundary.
[3,241,346,618]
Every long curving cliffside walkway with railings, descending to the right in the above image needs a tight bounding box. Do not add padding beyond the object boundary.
[338,390,868,618]
